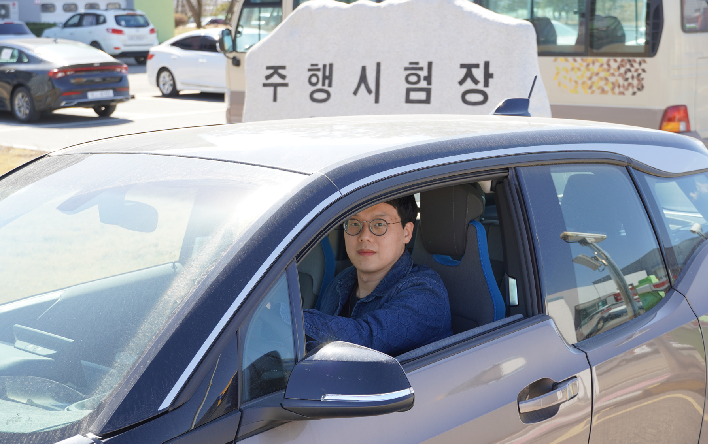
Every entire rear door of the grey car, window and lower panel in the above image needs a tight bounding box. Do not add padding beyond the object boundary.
[519,164,706,443]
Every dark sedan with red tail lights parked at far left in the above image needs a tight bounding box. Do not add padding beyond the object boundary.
[0,38,130,123]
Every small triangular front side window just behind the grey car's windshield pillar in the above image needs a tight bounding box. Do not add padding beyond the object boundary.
[241,274,296,402]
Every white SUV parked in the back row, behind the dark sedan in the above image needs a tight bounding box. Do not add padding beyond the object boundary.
[42,9,159,64]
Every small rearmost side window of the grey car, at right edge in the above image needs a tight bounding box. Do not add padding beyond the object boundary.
[637,173,708,279]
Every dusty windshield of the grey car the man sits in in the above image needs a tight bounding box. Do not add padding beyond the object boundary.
[0,154,303,442]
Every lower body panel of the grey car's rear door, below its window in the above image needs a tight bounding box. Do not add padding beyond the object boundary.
[577,291,706,443]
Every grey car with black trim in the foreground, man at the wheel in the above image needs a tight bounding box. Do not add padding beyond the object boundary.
[0,116,708,444]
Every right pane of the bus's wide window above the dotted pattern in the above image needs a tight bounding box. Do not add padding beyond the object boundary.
[590,0,647,55]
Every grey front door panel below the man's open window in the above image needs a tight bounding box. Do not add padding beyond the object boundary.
[244,316,591,444]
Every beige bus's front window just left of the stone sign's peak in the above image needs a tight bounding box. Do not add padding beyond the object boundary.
[236,1,283,52]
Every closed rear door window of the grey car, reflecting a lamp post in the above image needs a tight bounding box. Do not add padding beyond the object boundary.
[519,165,669,344]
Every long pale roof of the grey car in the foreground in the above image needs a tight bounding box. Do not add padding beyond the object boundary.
[53,115,708,178]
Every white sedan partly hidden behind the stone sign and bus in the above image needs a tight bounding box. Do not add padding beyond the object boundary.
[147,28,226,96]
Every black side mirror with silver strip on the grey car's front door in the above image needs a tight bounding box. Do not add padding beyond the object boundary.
[282,342,415,419]
